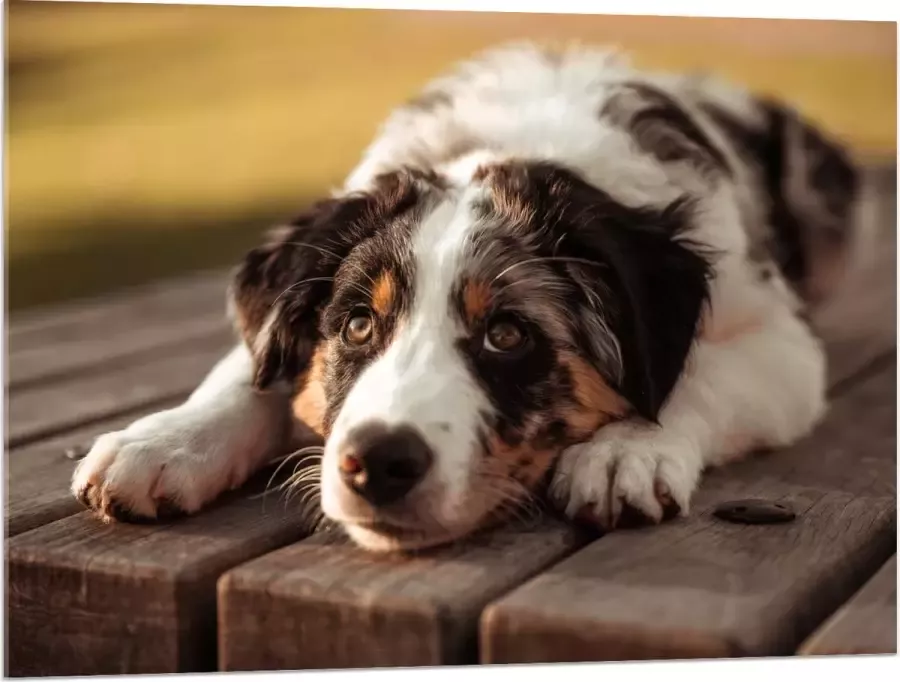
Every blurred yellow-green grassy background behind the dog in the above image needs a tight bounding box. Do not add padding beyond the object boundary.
[4,0,897,310]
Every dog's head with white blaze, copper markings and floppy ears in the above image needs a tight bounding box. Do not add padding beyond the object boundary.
[233,163,710,550]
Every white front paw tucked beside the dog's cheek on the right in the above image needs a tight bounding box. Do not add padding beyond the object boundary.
[550,422,703,530]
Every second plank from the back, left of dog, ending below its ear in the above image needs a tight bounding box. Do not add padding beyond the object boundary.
[6,329,234,448]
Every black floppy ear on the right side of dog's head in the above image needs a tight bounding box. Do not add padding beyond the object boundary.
[528,165,714,421]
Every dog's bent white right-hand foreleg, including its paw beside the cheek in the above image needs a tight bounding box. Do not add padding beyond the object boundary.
[551,308,826,529]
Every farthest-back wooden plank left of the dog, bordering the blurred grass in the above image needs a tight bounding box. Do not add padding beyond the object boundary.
[7,273,229,389]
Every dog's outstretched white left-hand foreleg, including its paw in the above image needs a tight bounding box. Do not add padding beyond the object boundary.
[72,344,291,520]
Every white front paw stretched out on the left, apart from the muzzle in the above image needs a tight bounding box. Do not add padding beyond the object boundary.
[72,409,243,523]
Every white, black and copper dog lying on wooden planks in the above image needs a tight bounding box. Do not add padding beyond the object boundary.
[72,43,860,552]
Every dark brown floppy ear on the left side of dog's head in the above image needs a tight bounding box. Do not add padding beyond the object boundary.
[229,172,432,390]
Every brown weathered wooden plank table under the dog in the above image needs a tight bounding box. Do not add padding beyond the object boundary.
[6,168,896,676]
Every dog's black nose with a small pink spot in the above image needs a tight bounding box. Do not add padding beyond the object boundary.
[339,424,434,507]
